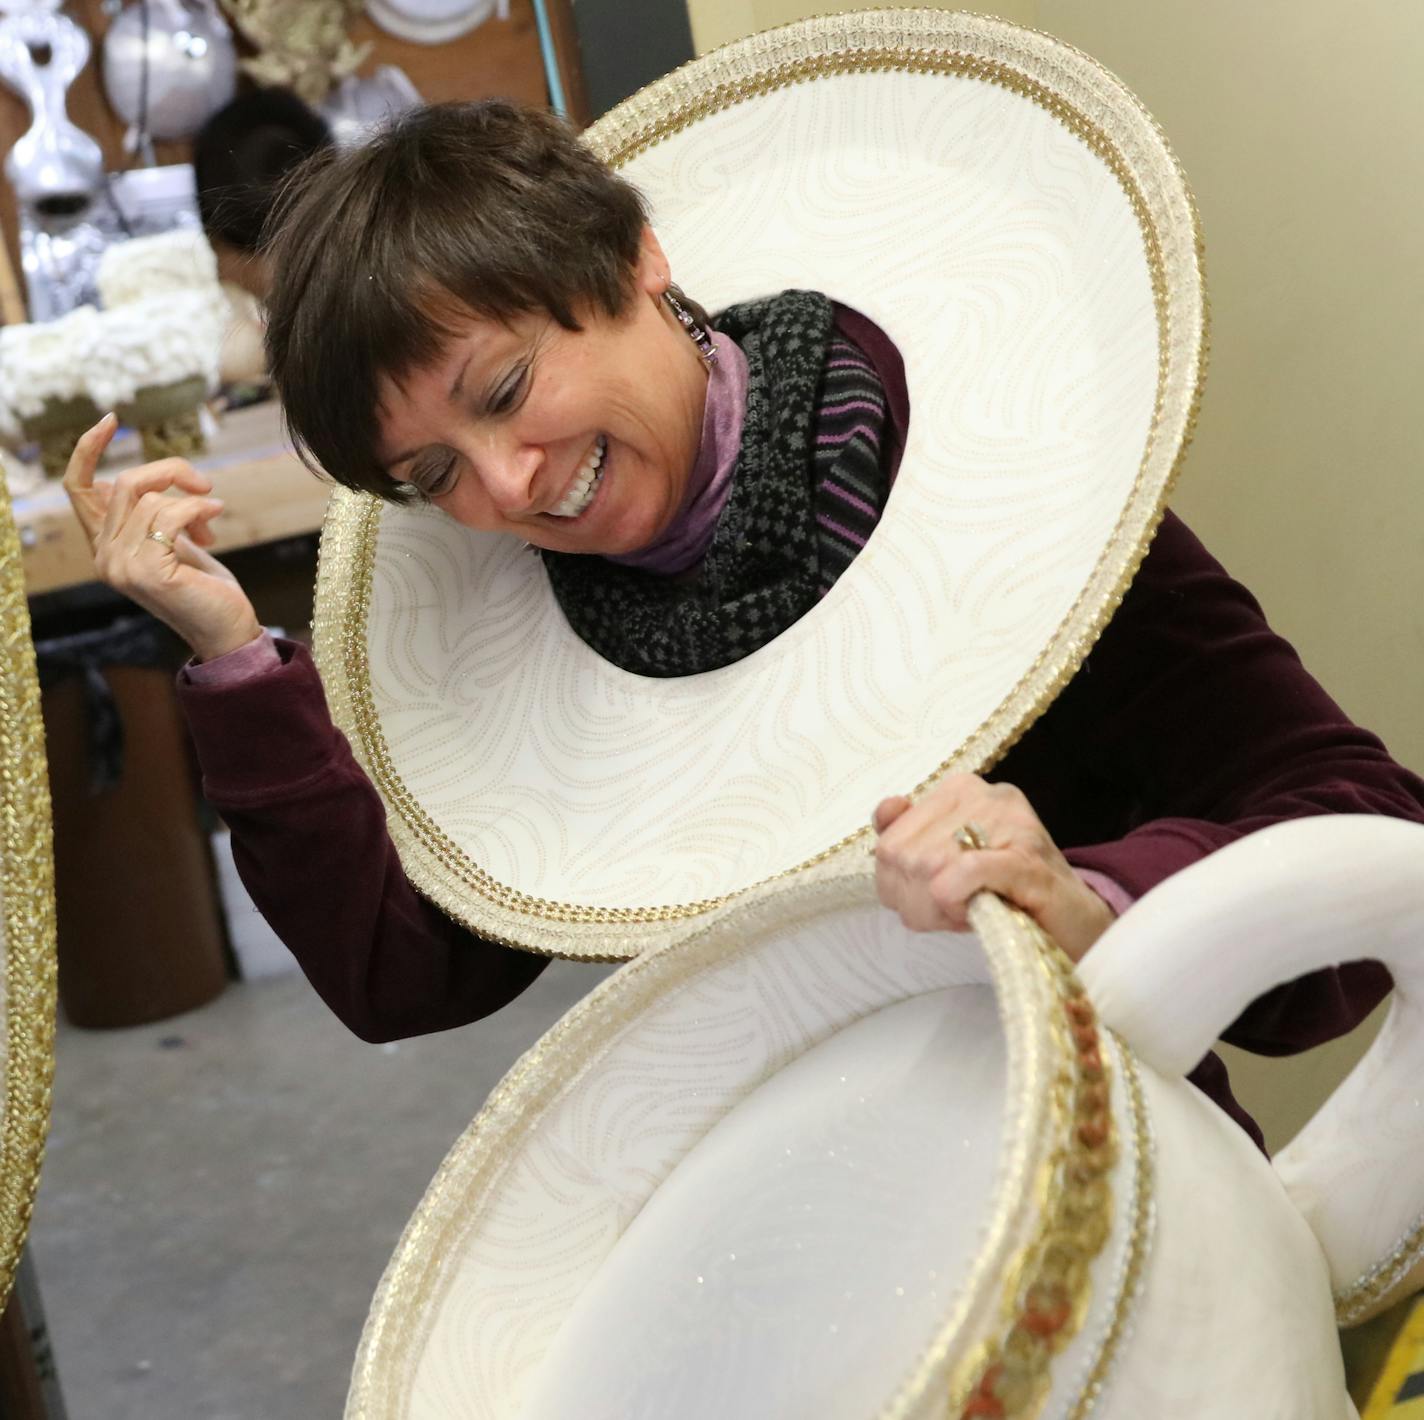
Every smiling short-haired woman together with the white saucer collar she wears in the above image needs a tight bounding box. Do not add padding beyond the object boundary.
[68,66,1424,1156]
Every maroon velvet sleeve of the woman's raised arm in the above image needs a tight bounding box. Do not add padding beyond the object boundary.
[178,641,548,1041]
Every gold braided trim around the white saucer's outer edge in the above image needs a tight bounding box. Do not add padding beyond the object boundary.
[316,10,1208,960]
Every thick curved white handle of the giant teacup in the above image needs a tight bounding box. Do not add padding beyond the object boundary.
[1078,815,1424,1322]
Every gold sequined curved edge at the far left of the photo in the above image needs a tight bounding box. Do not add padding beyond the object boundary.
[0,464,56,1309]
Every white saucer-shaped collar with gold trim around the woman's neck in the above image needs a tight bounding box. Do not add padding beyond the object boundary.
[316,10,1205,959]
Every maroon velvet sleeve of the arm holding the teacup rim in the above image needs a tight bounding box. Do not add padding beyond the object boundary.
[1065,516,1424,1054]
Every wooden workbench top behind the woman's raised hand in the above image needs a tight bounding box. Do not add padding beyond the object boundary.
[14,402,330,597]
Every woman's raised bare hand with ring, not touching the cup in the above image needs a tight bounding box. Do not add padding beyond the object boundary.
[64,414,262,661]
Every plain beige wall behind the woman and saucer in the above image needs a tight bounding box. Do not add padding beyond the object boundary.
[689,0,1424,1135]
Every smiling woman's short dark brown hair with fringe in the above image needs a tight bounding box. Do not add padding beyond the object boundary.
[266,100,646,498]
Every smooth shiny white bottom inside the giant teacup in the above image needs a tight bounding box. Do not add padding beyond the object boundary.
[520,987,1004,1420]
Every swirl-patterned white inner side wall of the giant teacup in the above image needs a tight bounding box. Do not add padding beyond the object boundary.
[390,889,988,1420]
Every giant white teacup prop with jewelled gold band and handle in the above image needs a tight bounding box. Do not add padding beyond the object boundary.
[347,816,1424,1420]
